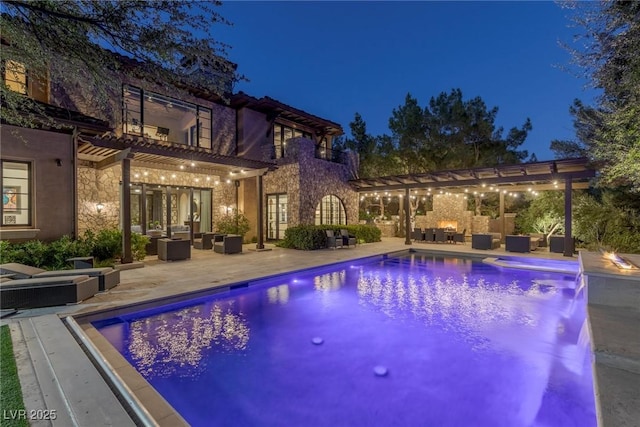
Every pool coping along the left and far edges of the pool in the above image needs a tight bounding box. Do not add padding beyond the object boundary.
[64,248,595,426]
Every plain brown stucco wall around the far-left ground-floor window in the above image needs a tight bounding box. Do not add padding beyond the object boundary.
[0,125,75,241]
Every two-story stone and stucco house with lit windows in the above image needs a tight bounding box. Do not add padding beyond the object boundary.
[0,54,358,255]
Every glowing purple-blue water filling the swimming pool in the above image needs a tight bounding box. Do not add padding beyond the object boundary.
[94,253,596,427]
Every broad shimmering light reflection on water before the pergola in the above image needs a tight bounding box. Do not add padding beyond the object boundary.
[357,270,558,342]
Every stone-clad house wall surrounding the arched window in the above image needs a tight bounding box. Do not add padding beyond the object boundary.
[264,138,358,227]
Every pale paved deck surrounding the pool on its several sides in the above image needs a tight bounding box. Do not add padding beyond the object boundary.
[2,238,640,427]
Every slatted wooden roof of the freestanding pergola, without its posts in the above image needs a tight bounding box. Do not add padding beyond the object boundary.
[349,158,596,193]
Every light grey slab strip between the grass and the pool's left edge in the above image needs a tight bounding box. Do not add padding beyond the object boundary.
[19,315,135,427]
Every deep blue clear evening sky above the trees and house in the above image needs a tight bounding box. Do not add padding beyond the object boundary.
[214,1,594,160]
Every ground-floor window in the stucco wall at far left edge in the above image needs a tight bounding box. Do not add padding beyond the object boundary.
[0,160,31,226]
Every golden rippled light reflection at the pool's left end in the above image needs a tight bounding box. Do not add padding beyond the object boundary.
[128,304,250,379]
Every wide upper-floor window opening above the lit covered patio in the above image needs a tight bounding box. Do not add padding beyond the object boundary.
[122,86,212,148]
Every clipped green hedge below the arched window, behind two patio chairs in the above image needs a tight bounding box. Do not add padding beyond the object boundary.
[278,225,382,251]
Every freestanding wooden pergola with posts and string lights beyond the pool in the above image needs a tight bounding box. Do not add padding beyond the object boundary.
[350,158,596,256]
